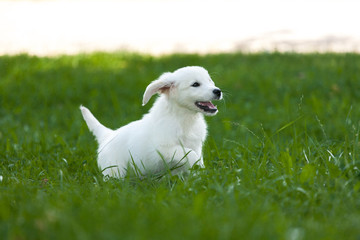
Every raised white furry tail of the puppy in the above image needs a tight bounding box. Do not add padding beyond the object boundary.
[80,106,113,144]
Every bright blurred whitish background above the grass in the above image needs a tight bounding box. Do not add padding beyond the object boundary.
[0,0,360,56]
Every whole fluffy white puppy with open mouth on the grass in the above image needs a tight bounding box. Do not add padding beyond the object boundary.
[80,67,222,178]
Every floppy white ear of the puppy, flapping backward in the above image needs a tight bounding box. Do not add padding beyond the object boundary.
[143,72,174,106]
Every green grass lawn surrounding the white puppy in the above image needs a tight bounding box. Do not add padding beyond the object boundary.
[0,53,360,240]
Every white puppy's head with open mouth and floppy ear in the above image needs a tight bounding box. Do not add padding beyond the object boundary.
[143,67,222,115]
